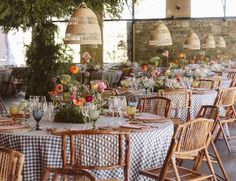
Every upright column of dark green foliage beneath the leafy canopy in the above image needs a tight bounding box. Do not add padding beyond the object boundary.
[26,23,72,99]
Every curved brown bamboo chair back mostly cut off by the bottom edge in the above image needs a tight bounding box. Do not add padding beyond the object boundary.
[41,168,96,181]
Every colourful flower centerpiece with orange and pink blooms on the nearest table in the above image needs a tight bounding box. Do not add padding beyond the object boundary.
[49,65,104,123]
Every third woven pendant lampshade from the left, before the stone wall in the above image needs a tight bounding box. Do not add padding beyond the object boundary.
[183,30,200,50]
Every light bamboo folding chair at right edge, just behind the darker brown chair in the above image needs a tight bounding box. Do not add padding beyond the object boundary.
[214,87,236,152]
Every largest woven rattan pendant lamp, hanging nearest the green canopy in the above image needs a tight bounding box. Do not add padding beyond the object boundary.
[64,2,102,45]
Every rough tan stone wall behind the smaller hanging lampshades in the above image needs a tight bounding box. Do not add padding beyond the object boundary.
[134,18,236,62]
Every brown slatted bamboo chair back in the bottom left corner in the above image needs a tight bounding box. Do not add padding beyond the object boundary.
[0,147,24,181]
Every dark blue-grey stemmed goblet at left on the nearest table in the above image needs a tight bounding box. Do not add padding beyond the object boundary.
[32,102,44,130]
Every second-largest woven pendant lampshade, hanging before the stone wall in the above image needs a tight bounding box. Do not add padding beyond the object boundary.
[149,21,173,46]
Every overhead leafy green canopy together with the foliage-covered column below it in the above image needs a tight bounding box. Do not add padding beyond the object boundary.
[0,0,129,98]
